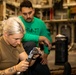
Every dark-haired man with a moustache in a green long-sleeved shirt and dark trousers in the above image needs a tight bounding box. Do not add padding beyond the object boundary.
[18,0,52,75]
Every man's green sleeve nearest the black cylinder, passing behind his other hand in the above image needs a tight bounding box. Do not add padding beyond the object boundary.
[40,22,52,54]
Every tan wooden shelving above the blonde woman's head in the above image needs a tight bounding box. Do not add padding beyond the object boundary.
[2,0,23,20]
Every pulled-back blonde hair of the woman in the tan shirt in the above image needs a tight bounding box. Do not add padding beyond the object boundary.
[3,17,25,35]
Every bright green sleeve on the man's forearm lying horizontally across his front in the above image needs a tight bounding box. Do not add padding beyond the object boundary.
[22,33,39,42]
